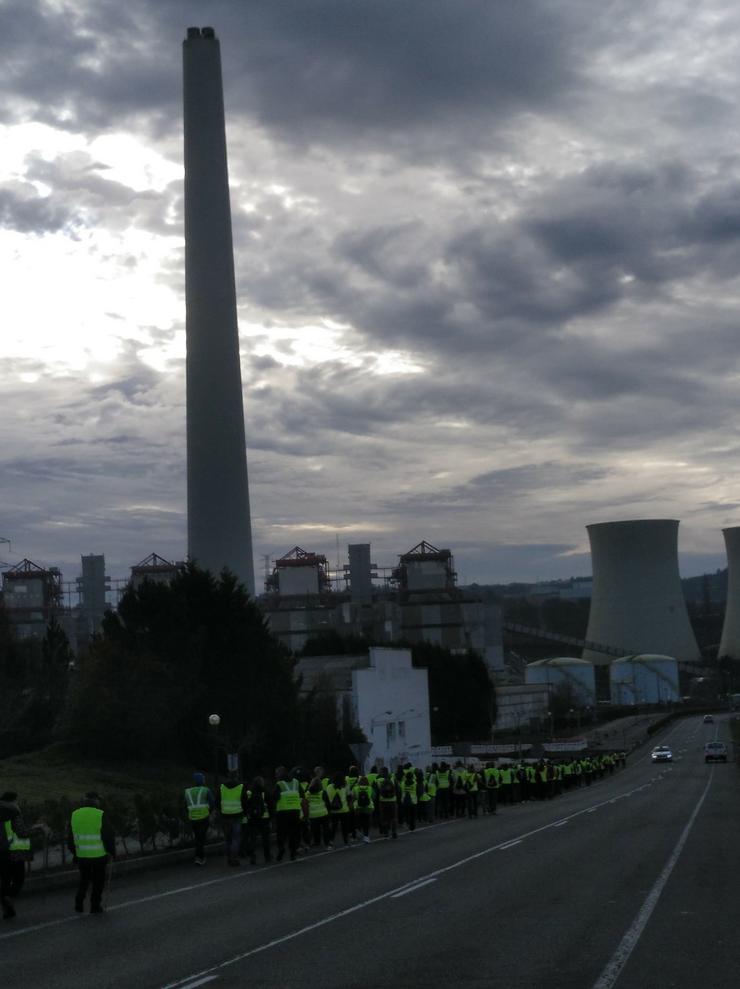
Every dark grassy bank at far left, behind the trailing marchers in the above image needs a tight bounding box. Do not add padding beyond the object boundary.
[0,744,192,804]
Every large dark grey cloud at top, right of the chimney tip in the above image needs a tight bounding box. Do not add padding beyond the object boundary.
[231,0,579,147]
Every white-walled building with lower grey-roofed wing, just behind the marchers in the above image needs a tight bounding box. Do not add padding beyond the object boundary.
[296,646,432,769]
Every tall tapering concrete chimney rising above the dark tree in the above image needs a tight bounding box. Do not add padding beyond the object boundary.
[183,27,254,595]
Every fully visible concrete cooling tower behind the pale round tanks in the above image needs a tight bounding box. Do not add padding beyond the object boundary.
[583,519,699,664]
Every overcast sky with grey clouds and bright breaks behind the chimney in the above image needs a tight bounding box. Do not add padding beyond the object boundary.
[0,0,740,586]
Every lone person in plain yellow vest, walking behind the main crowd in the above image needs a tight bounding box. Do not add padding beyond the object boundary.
[67,792,116,913]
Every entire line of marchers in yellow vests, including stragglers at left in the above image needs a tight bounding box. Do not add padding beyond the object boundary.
[0,752,626,920]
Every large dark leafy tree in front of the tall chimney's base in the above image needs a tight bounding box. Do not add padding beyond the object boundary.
[68,564,298,765]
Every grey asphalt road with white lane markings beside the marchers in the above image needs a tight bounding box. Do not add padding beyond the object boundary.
[0,718,740,989]
